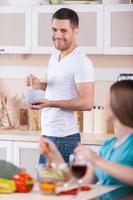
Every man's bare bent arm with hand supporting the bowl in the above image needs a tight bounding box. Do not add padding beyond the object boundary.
[30,82,94,111]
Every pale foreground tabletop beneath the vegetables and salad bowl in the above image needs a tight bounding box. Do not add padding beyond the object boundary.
[0,185,117,200]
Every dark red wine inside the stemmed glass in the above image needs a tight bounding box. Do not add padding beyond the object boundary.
[71,165,87,179]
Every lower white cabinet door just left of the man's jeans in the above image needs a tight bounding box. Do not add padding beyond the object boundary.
[13,141,39,178]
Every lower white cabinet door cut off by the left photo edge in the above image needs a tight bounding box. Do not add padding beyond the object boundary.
[0,140,13,162]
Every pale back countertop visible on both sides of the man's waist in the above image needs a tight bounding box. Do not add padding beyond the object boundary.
[0,129,113,145]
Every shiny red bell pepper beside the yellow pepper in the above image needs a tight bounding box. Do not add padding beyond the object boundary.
[13,172,34,193]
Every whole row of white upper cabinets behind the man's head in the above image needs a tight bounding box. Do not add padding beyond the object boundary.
[0,4,133,55]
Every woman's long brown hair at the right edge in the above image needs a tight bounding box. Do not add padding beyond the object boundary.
[110,80,133,128]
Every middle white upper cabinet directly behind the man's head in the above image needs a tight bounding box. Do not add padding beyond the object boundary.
[32,4,103,54]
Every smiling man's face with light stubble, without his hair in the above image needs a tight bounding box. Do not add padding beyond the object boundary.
[52,19,78,51]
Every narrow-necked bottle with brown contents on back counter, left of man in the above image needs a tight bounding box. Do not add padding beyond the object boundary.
[19,98,29,130]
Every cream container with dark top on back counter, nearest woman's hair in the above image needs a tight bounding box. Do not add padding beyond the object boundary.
[94,106,107,134]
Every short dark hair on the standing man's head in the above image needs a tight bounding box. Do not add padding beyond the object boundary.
[52,8,79,27]
